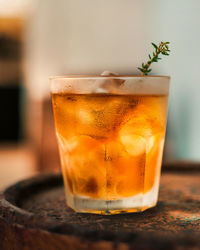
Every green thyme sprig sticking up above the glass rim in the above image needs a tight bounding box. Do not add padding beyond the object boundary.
[138,42,170,75]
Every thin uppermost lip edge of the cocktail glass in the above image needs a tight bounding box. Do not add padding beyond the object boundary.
[49,75,171,80]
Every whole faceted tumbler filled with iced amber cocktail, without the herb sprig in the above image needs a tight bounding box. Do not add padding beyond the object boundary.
[51,76,169,214]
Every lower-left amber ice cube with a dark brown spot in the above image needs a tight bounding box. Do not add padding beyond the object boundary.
[58,135,106,198]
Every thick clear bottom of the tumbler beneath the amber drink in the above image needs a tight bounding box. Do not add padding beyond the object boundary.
[67,182,158,215]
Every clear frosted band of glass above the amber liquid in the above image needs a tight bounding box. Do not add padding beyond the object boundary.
[50,75,170,95]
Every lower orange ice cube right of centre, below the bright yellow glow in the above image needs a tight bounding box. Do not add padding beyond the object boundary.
[105,141,146,199]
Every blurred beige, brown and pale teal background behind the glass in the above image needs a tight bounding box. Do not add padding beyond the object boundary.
[0,0,200,189]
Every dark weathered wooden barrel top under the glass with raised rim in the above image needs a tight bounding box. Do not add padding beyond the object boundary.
[0,162,200,249]
